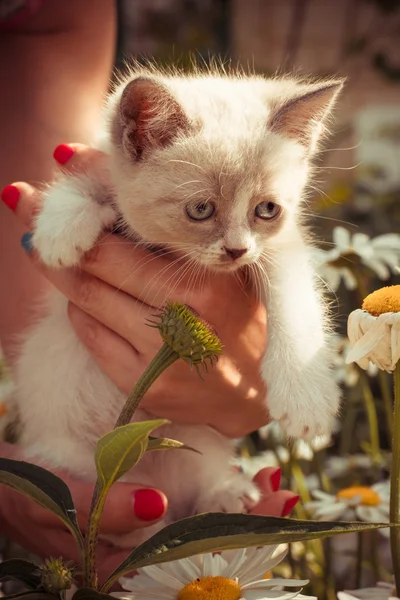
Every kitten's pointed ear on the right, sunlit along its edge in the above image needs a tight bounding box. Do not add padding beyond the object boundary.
[270,80,344,152]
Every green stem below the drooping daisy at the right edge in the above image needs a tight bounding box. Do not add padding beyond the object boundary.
[390,361,400,596]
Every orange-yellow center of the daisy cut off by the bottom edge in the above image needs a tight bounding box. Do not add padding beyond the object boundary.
[177,577,242,600]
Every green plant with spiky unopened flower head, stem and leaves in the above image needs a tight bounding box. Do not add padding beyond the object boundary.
[0,303,394,600]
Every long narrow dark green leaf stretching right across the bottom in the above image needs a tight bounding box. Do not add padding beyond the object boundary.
[102,513,388,591]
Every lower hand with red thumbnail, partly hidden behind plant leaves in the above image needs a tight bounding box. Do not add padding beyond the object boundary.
[0,443,167,581]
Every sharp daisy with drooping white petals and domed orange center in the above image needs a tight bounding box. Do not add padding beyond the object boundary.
[346,285,400,373]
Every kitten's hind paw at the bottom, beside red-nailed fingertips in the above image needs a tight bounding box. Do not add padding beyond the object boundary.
[194,473,261,514]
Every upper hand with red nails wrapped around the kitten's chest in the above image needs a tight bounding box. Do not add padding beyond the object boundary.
[2,144,268,437]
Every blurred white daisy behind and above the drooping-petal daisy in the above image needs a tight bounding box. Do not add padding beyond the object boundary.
[314,227,400,291]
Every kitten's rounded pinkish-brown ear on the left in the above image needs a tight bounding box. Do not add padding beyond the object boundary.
[115,77,189,160]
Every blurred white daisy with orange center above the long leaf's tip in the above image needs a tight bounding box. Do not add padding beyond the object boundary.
[304,481,390,536]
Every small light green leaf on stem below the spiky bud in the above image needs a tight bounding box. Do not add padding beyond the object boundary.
[95,419,168,495]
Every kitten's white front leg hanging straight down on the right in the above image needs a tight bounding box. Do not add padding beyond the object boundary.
[262,241,340,439]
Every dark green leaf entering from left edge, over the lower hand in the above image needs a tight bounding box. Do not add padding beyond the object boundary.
[0,458,83,548]
